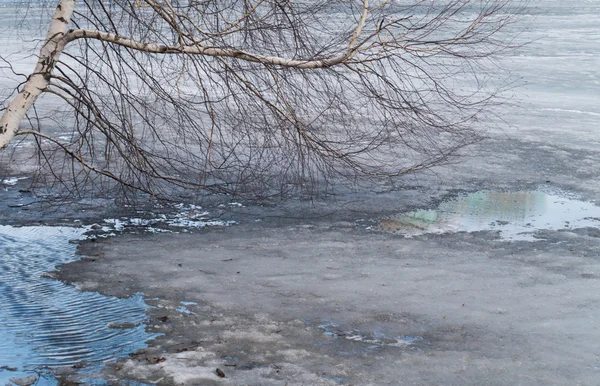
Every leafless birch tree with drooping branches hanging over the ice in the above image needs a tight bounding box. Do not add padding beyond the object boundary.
[0,0,522,198]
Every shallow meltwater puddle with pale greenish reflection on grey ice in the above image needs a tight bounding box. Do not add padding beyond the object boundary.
[378,191,600,240]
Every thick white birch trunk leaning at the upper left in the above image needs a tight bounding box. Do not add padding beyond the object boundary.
[0,0,75,150]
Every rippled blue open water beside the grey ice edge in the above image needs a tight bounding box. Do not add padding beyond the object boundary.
[0,226,152,384]
